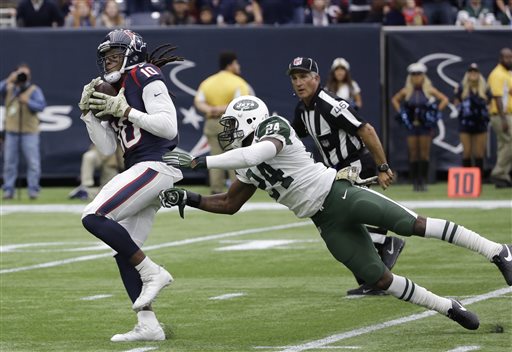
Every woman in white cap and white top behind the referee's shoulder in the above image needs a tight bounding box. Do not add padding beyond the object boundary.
[326,57,363,110]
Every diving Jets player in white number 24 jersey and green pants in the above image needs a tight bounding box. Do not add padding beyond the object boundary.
[160,96,512,330]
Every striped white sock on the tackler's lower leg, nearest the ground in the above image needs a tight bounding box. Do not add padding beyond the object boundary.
[386,274,452,315]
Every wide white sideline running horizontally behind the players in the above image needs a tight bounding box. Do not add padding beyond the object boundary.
[0,199,512,215]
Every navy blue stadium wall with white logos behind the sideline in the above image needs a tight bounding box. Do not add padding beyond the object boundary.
[0,25,512,180]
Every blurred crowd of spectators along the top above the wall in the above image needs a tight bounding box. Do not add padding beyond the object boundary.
[0,0,512,30]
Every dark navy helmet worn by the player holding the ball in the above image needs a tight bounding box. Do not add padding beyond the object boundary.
[97,29,147,83]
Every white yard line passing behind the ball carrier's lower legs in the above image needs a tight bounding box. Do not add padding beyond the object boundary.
[0,221,312,274]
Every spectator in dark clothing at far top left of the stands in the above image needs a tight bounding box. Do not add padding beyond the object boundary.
[16,0,64,27]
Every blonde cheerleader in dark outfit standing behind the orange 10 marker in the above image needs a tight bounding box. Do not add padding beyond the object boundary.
[454,63,491,177]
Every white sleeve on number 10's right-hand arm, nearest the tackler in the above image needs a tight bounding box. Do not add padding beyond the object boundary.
[128,80,178,140]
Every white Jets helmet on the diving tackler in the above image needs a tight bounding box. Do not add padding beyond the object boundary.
[217,95,269,150]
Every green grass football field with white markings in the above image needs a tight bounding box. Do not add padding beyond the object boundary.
[0,184,512,352]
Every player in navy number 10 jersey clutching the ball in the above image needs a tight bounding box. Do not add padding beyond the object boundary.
[78,29,183,342]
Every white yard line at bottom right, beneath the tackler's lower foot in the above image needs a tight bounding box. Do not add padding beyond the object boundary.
[279,287,512,352]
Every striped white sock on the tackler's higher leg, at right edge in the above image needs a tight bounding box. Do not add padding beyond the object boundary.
[425,218,503,260]
